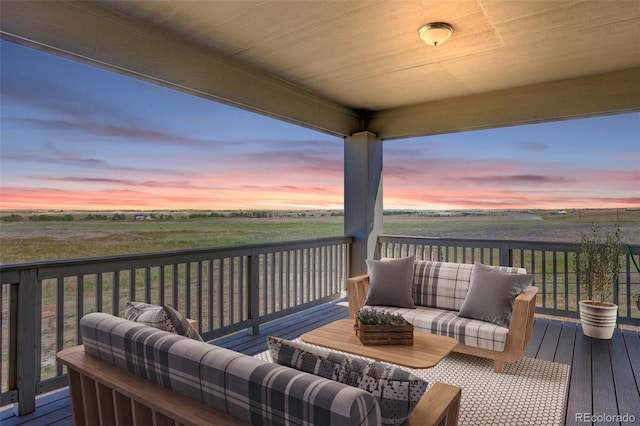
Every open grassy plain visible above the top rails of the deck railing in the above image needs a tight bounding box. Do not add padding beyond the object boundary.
[0,209,640,264]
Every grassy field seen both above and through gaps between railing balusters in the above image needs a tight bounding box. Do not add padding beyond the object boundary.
[0,210,640,386]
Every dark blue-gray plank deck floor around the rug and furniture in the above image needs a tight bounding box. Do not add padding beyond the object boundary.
[0,301,640,426]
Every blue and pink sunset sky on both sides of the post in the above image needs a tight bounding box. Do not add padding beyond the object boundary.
[0,41,640,210]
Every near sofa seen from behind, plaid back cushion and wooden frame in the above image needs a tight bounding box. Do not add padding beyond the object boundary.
[58,313,461,426]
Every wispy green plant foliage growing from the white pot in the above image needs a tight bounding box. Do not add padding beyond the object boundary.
[575,224,623,303]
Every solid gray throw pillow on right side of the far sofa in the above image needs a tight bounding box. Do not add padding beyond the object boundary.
[458,263,533,328]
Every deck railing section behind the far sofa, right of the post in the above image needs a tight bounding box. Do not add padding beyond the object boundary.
[378,235,640,326]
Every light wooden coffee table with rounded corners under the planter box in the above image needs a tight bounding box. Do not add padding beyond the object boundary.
[300,319,458,368]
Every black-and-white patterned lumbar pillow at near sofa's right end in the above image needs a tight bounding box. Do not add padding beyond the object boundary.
[267,336,428,425]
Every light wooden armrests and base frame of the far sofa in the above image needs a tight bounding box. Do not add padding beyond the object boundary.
[347,274,538,373]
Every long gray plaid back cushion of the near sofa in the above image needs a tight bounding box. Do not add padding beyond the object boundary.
[80,313,380,426]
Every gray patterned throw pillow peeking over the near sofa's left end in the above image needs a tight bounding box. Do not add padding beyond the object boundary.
[124,302,203,342]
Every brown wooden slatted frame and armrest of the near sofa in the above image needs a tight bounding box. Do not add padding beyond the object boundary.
[57,345,461,426]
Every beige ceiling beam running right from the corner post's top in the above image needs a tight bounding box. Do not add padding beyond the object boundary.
[365,68,640,139]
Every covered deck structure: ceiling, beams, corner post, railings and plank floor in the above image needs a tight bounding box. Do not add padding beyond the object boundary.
[0,0,640,425]
